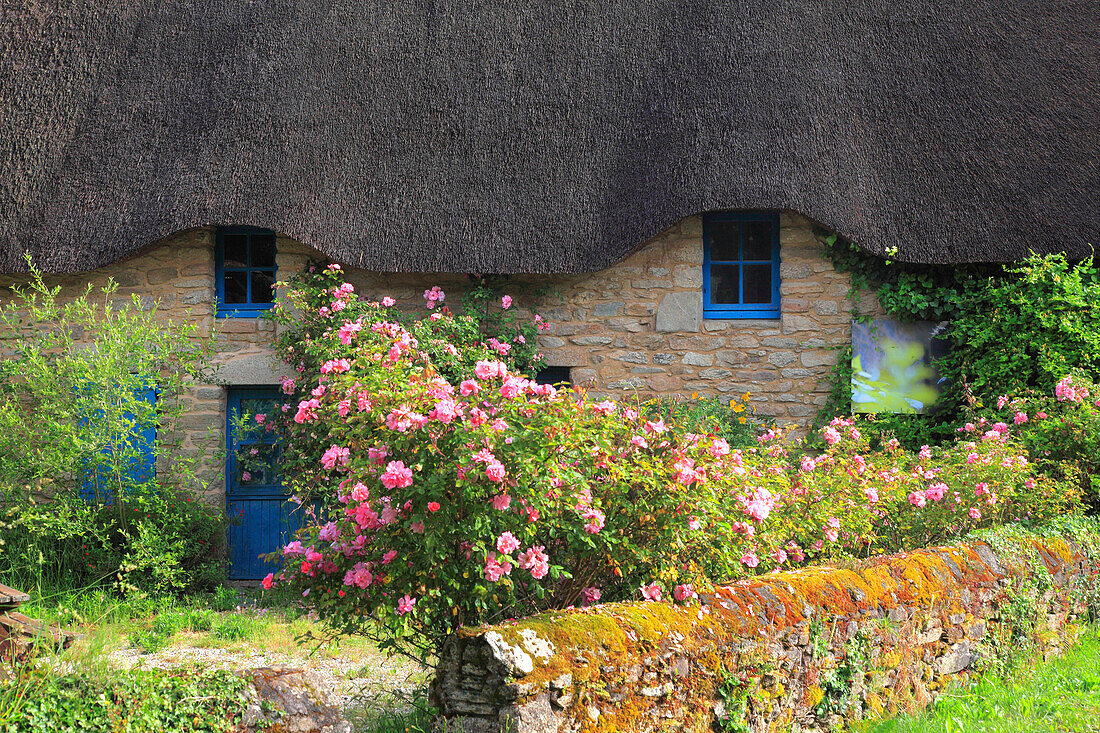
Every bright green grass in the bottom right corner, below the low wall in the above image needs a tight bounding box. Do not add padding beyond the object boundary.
[857,626,1100,733]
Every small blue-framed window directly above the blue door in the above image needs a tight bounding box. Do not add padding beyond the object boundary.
[215,227,275,318]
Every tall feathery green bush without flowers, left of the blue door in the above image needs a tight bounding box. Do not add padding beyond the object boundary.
[0,263,224,590]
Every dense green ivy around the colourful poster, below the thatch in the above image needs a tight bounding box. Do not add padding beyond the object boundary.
[815,230,1100,447]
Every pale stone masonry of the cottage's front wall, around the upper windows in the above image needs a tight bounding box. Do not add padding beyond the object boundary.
[0,212,873,501]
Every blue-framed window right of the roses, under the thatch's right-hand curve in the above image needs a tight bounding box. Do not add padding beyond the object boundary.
[703,211,780,318]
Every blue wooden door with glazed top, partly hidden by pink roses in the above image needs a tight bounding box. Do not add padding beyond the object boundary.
[226,387,305,580]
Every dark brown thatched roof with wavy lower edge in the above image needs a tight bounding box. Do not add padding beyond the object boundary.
[0,0,1100,272]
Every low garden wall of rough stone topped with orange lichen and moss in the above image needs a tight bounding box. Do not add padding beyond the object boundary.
[432,530,1100,733]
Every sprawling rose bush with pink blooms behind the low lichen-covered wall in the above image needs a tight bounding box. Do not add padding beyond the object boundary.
[255,265,1065,649]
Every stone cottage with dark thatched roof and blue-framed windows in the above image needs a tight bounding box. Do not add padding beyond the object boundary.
[0,0,1100,578]
